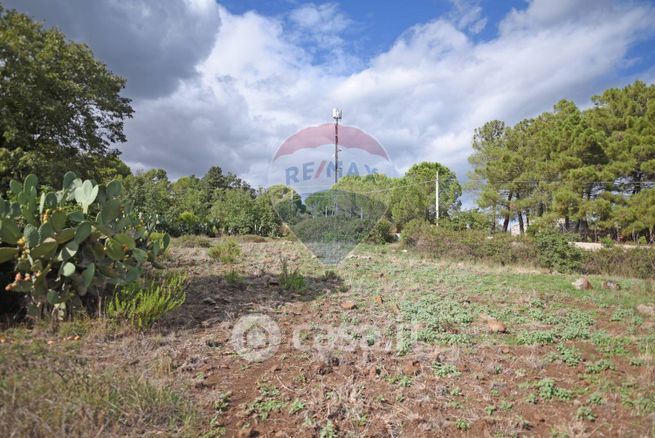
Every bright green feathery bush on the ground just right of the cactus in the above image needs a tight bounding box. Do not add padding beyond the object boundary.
[105,274,187,330]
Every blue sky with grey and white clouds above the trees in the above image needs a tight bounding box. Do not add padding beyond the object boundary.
[3,0,655,185]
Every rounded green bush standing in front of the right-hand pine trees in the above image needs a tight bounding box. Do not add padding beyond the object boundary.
[533,228,585,272]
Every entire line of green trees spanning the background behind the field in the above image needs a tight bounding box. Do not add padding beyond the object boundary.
[0,6,655,242]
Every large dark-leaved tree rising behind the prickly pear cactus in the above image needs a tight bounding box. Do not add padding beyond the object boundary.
[0,6,133,188]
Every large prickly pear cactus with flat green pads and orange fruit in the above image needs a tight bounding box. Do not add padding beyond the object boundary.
[0,172,170,316]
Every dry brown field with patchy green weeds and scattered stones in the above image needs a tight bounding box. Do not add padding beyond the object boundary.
[0,240,655,437]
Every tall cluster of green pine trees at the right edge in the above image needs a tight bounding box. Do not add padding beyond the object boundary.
[468,81,655,242]
